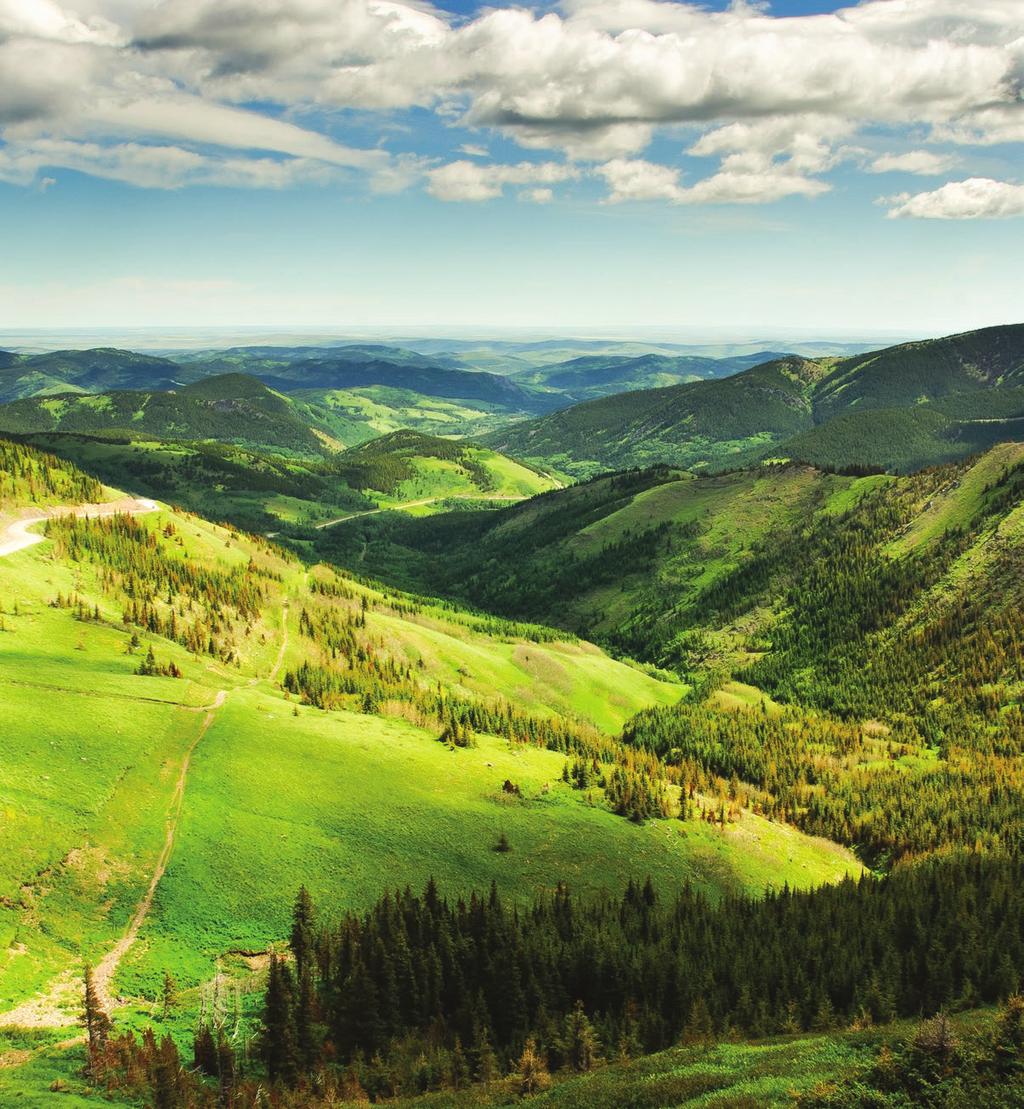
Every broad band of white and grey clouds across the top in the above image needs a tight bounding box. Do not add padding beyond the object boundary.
[0,0,1024,203]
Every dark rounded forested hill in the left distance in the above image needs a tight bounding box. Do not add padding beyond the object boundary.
[0,374,325,456]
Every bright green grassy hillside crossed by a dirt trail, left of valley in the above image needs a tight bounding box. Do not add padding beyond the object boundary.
[0,436,856,1069]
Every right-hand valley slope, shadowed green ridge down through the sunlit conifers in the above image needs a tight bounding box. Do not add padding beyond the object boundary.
[312,444,1024,863]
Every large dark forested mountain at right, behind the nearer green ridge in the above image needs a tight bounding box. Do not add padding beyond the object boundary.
[486,325,1024,476]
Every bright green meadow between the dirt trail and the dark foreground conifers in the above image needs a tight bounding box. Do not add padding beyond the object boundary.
[115,689,860,996]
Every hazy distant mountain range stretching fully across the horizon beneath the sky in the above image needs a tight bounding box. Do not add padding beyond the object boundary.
[0,325,1024,477]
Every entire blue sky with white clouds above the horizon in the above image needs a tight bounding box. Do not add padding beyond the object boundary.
[0,0,1024,337]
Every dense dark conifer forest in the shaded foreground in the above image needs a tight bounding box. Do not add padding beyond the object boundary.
[234,855,1024,1097]
